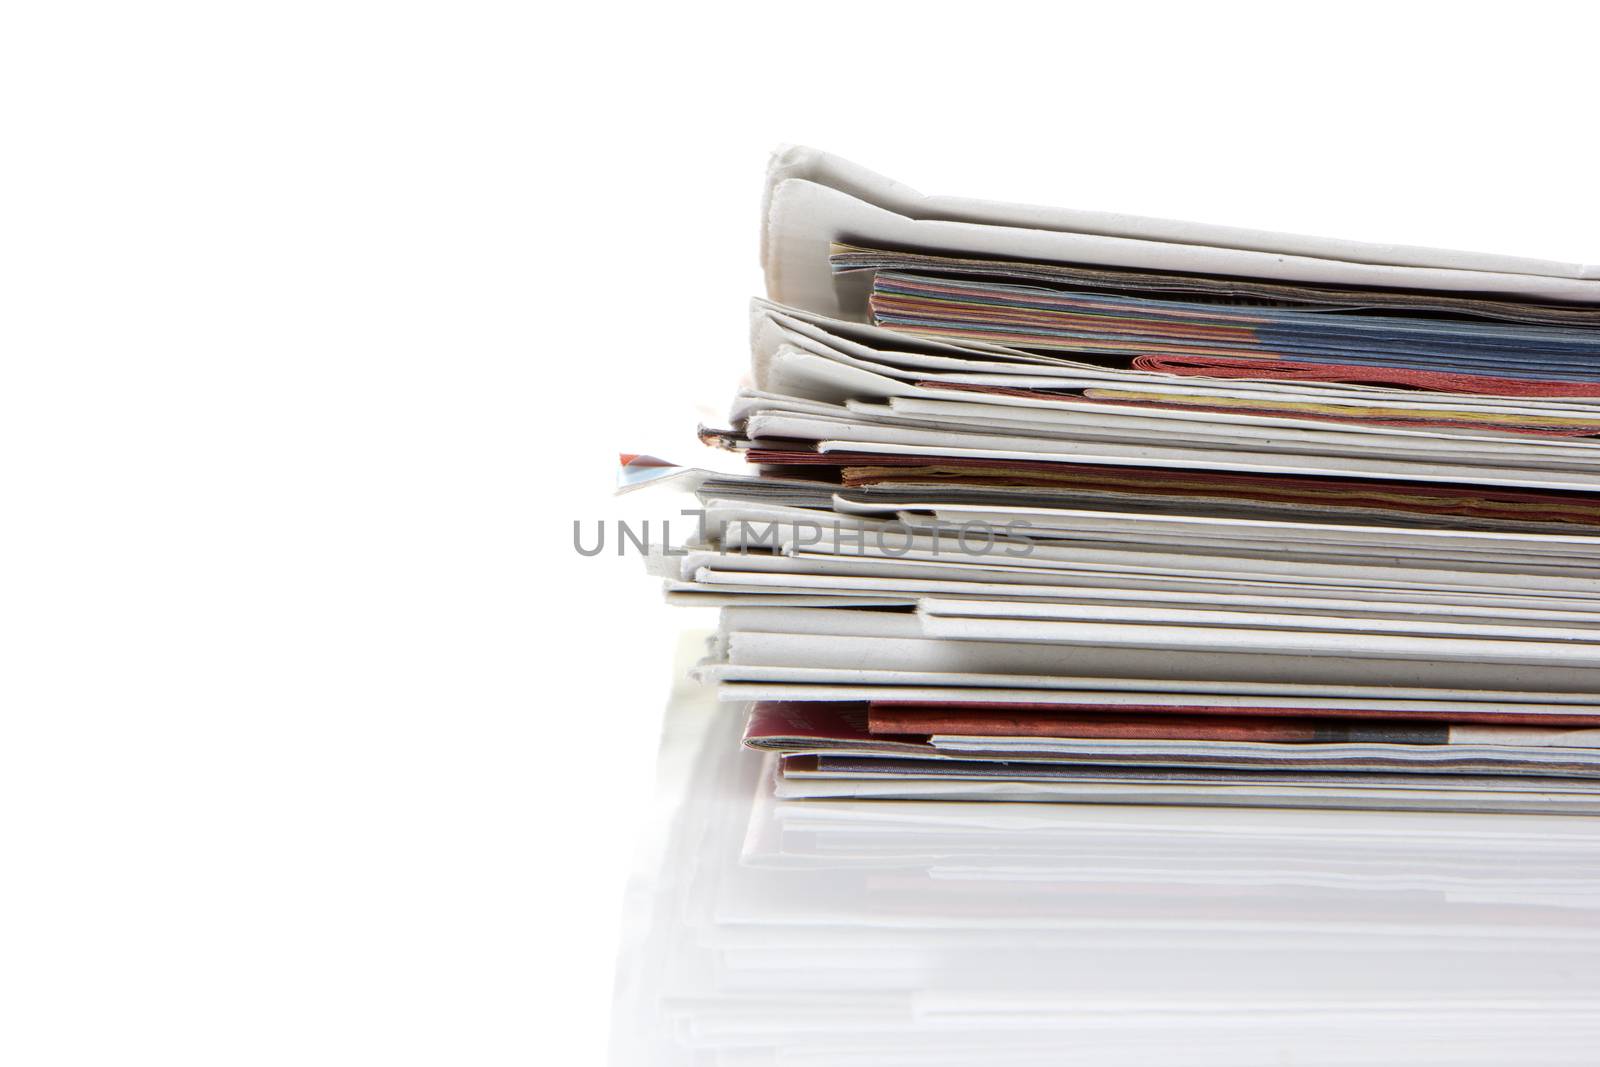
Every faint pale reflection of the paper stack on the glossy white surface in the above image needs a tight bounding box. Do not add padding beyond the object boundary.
[613,633,1600,1067]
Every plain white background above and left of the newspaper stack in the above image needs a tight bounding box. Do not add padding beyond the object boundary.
[0,0,1600,1065]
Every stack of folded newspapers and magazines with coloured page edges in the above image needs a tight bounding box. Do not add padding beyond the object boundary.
[630,149,1600,814]
